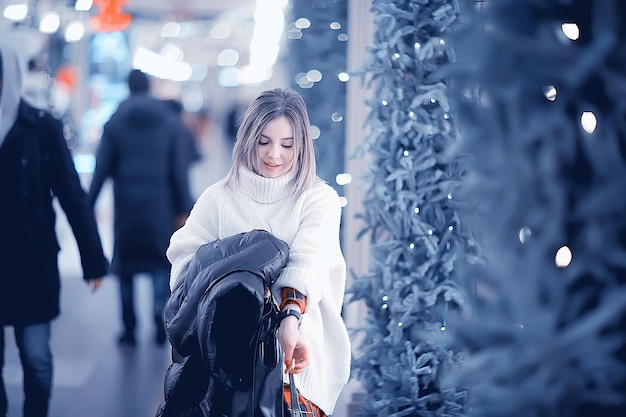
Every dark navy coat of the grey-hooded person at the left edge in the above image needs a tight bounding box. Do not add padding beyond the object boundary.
[0,101,108,324]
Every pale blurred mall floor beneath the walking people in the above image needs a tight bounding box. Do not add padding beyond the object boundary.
[4,274,170,417]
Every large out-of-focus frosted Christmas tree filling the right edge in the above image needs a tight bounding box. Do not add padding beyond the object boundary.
[446,0,626,417]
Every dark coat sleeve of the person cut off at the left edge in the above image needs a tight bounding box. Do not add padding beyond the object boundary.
[43,115,109,280]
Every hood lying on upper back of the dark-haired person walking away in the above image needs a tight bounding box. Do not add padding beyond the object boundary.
[114,94,172,127]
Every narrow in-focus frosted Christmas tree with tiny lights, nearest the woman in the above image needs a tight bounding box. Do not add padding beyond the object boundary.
[350,1,476,417]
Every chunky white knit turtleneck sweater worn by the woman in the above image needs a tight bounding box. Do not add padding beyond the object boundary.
[167,168,350,415]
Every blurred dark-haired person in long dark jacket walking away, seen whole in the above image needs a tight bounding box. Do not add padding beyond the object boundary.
[89,70,191,345]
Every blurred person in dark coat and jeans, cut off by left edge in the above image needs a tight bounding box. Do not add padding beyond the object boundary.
[0,42,109,417]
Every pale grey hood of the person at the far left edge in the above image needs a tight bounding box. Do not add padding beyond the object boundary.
[0,42,22,146]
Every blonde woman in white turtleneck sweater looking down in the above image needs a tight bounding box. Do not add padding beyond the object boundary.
[167,89,350,416]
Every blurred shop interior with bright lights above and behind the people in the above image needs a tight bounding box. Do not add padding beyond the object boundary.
[0,0,348,194]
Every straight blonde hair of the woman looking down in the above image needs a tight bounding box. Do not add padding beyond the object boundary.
[227,88,317,193]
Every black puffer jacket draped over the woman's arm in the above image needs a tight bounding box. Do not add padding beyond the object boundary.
[157,230,288,417]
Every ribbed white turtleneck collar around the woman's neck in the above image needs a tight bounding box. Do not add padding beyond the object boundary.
[237,167,296,204]
